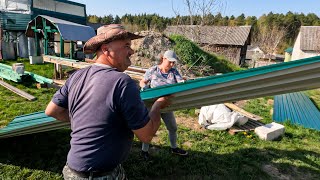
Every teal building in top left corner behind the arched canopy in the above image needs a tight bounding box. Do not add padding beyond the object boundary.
[0,0,87,59]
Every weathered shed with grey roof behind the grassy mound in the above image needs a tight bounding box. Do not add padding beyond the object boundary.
[164,25,251,65]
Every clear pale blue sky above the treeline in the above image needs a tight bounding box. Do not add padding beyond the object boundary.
[71,0,320,17]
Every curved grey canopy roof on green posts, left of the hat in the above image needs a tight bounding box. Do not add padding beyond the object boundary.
[26,15,95,41]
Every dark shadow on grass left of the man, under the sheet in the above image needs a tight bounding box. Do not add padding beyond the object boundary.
[0,129,70,174]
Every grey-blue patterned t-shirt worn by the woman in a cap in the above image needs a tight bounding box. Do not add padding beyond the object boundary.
[144,65,184,88]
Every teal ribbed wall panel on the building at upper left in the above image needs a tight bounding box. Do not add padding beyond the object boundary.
[0,12,31,31]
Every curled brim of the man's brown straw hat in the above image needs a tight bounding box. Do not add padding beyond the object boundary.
[83,32,144,54]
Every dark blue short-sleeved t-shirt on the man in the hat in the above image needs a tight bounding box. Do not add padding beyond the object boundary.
[52,64,150,171]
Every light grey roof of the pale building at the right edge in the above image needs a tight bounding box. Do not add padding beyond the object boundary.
[300,26,320,51]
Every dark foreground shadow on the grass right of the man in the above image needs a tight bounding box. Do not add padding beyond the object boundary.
[124,143,320,180]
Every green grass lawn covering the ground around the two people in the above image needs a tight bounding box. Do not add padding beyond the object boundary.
[0,59,320,180]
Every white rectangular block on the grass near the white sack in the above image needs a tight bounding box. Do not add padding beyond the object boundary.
[254,122,285,141]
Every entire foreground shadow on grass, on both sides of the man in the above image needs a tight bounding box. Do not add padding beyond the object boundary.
[0,129,320,179]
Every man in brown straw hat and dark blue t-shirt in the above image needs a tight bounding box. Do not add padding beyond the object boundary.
[45,24,169,179]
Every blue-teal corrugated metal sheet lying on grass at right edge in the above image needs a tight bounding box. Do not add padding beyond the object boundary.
[273,92,320,130]
